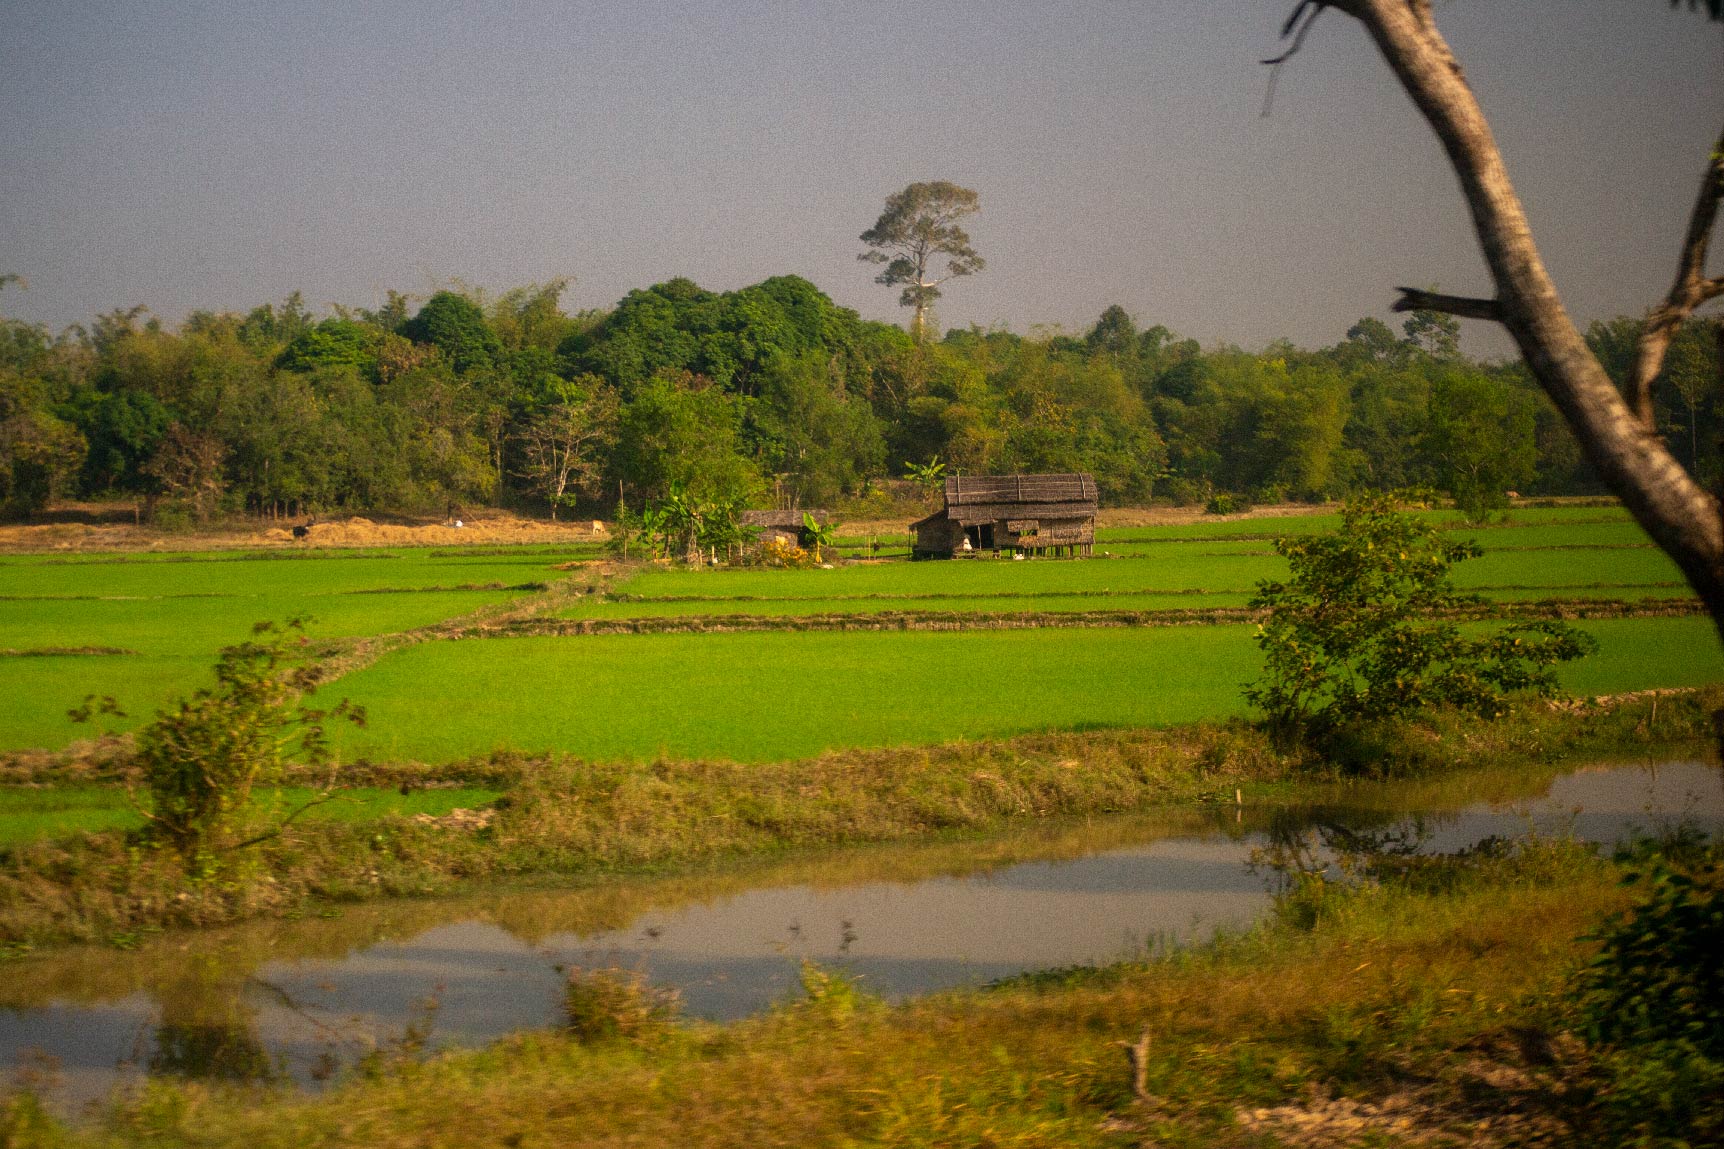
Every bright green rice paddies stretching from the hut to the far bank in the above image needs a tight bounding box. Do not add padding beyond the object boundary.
[0,507,1724,759]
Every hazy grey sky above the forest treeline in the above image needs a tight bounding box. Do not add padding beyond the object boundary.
[0,0,1724,354]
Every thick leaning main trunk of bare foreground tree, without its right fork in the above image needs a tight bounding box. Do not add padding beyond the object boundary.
[1331,0,1724,638]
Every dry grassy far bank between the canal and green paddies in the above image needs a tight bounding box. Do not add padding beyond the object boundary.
[0,688,1721,949]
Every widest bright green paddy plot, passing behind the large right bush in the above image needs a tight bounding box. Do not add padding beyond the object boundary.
[320,618,1724,763]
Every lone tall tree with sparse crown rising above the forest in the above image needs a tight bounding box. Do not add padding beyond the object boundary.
[857,179,988,342]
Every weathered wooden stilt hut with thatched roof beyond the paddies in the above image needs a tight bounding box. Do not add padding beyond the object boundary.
[910,474,1096,559]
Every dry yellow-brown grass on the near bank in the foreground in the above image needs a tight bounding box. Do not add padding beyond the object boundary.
[9,824,1668,1149]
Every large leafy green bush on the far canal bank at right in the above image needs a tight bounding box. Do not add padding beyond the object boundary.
[1245,495,1596,745]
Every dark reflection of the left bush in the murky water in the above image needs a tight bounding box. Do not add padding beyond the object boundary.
[150,954,283,1082]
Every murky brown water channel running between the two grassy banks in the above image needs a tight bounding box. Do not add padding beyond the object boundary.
[0,764,1724,1096]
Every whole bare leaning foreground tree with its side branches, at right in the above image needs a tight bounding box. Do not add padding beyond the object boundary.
[1281,0,1724,652]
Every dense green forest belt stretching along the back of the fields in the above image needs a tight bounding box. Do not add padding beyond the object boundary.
[0,276,1724,521]
